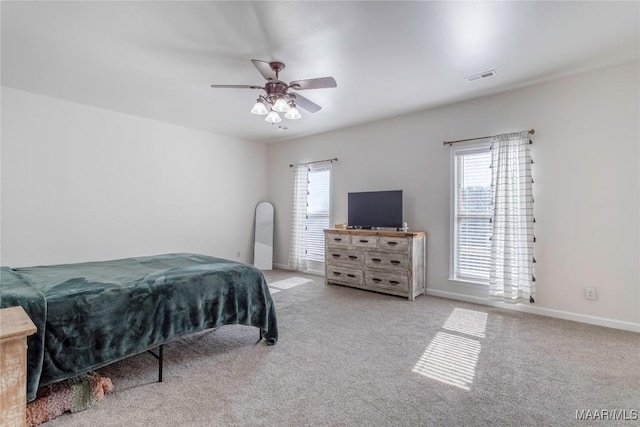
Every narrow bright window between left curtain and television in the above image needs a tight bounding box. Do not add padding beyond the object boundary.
[305,163,331,270]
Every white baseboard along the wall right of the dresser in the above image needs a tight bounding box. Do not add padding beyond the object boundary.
[427,289,640,332]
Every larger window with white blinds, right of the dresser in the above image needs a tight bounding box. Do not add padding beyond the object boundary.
[451,144,493,284]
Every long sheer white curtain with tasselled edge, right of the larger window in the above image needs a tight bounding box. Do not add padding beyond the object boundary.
[489,131,535,304]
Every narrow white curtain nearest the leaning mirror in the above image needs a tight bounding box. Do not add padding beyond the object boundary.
[289,165,309,270]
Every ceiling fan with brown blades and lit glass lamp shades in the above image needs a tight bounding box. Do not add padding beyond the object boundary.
[211,59,337,124]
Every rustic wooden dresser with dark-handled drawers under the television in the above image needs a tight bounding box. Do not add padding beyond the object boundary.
[324,229,426,301]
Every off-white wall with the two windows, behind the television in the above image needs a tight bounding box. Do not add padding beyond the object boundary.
[269,62,640,329]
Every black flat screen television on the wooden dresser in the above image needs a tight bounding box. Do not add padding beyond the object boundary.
[347,190,402,228]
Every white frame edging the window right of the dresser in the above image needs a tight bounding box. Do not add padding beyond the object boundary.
[449,140,491,287]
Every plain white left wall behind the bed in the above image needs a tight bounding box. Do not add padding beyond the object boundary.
[0,87,267,267]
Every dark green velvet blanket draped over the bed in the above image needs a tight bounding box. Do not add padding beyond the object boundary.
[0,254,278,401]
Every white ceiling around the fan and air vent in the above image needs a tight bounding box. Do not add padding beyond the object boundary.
[0,1,640,142]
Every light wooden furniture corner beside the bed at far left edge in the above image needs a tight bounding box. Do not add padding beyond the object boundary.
[0,306,36,427]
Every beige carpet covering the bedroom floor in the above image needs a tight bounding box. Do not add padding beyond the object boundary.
[45,270,640,427]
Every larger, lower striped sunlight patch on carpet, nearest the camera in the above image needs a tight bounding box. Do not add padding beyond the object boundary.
[412,332,480,390]
